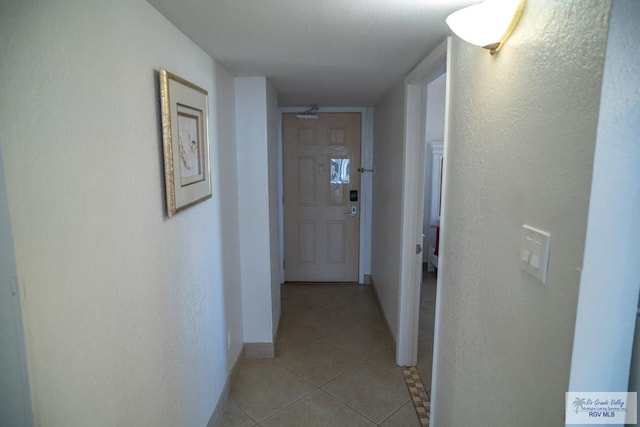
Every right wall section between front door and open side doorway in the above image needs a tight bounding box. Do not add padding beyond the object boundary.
[371,81,405,339]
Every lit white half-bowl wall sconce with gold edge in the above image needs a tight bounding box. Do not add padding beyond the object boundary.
[446,0,526,55]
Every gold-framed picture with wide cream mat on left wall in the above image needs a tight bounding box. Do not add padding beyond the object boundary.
[160,70,211,218]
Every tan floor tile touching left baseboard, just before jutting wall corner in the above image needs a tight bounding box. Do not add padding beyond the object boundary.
[229,359,315,422]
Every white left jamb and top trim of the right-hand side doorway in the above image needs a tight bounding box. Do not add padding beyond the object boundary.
[396,40,448,366]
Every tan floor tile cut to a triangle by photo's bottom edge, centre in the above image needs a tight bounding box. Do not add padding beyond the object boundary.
[260,390,375,427]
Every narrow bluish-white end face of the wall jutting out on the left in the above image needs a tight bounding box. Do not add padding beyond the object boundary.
[235,77,276,343]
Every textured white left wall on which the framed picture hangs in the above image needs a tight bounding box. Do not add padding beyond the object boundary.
[0,0,242,426]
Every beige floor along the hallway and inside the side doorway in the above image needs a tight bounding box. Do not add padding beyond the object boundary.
[221,275,435,427]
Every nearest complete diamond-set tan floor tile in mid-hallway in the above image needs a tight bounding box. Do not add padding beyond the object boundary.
[282,340,359,386]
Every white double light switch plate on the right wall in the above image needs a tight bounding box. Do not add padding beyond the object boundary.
[520,225,551,283]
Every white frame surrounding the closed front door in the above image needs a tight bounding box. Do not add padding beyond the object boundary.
[278,106,373,283]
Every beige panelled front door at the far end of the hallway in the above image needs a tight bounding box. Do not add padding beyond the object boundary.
[282,113,361,282]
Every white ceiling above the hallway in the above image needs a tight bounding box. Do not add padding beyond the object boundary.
[147,0,477,107]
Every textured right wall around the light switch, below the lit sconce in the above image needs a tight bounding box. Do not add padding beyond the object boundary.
[432,0,609,427]
